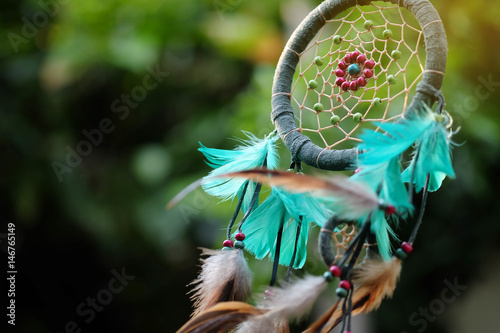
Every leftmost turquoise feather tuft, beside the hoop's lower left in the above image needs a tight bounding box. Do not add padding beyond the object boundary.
[198,131,279,211]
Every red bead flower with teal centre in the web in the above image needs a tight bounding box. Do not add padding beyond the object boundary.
[335,50,375,91]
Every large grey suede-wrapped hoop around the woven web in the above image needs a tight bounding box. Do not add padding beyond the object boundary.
[271,0,447,171]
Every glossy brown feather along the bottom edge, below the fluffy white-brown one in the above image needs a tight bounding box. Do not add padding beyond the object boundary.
[177,302,266,333]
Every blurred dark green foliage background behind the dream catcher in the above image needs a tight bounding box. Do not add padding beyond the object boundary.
[0,0,500,333]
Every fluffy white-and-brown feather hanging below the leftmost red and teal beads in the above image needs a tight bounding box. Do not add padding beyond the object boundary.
[191,249,252,316]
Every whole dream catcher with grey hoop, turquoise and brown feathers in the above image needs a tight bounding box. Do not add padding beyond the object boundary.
[170,0,455,332]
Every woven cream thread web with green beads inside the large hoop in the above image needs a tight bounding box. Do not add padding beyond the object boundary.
[291,2,425,149]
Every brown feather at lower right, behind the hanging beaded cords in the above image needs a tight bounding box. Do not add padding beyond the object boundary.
[305,258,401,333]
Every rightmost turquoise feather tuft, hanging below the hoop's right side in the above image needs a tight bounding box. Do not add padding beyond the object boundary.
[402,107,455,192]
